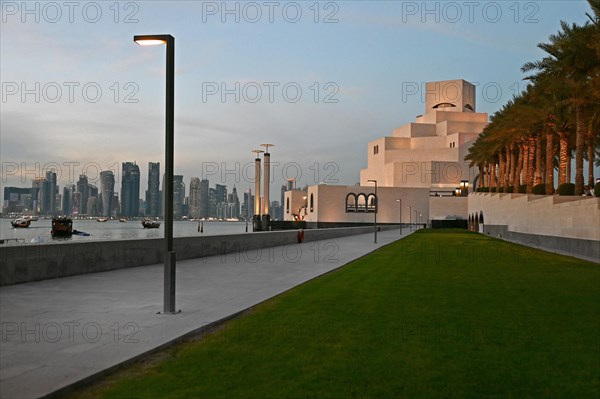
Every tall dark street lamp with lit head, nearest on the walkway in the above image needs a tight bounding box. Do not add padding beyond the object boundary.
[133,35,176,313]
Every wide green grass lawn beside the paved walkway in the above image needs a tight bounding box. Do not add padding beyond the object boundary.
[73,230,600,399]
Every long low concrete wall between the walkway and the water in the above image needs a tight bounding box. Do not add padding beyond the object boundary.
[0,226,397,286]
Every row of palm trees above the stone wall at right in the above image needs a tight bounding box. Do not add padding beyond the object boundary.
[465,0,600,195]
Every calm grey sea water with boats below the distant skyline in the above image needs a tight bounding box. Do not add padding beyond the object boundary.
[0,219,252,245]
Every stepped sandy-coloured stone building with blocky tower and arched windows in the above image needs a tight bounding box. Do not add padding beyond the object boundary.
[284,80,488,227]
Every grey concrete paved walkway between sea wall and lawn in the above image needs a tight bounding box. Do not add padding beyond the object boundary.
[0,229,409,399]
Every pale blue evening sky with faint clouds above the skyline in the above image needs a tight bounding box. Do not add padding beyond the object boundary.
[0,0,589,206]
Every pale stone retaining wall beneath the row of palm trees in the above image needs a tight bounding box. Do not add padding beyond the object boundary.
[483,224,600,263]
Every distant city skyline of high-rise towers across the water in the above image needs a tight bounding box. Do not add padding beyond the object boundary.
[2,162,286,219]
